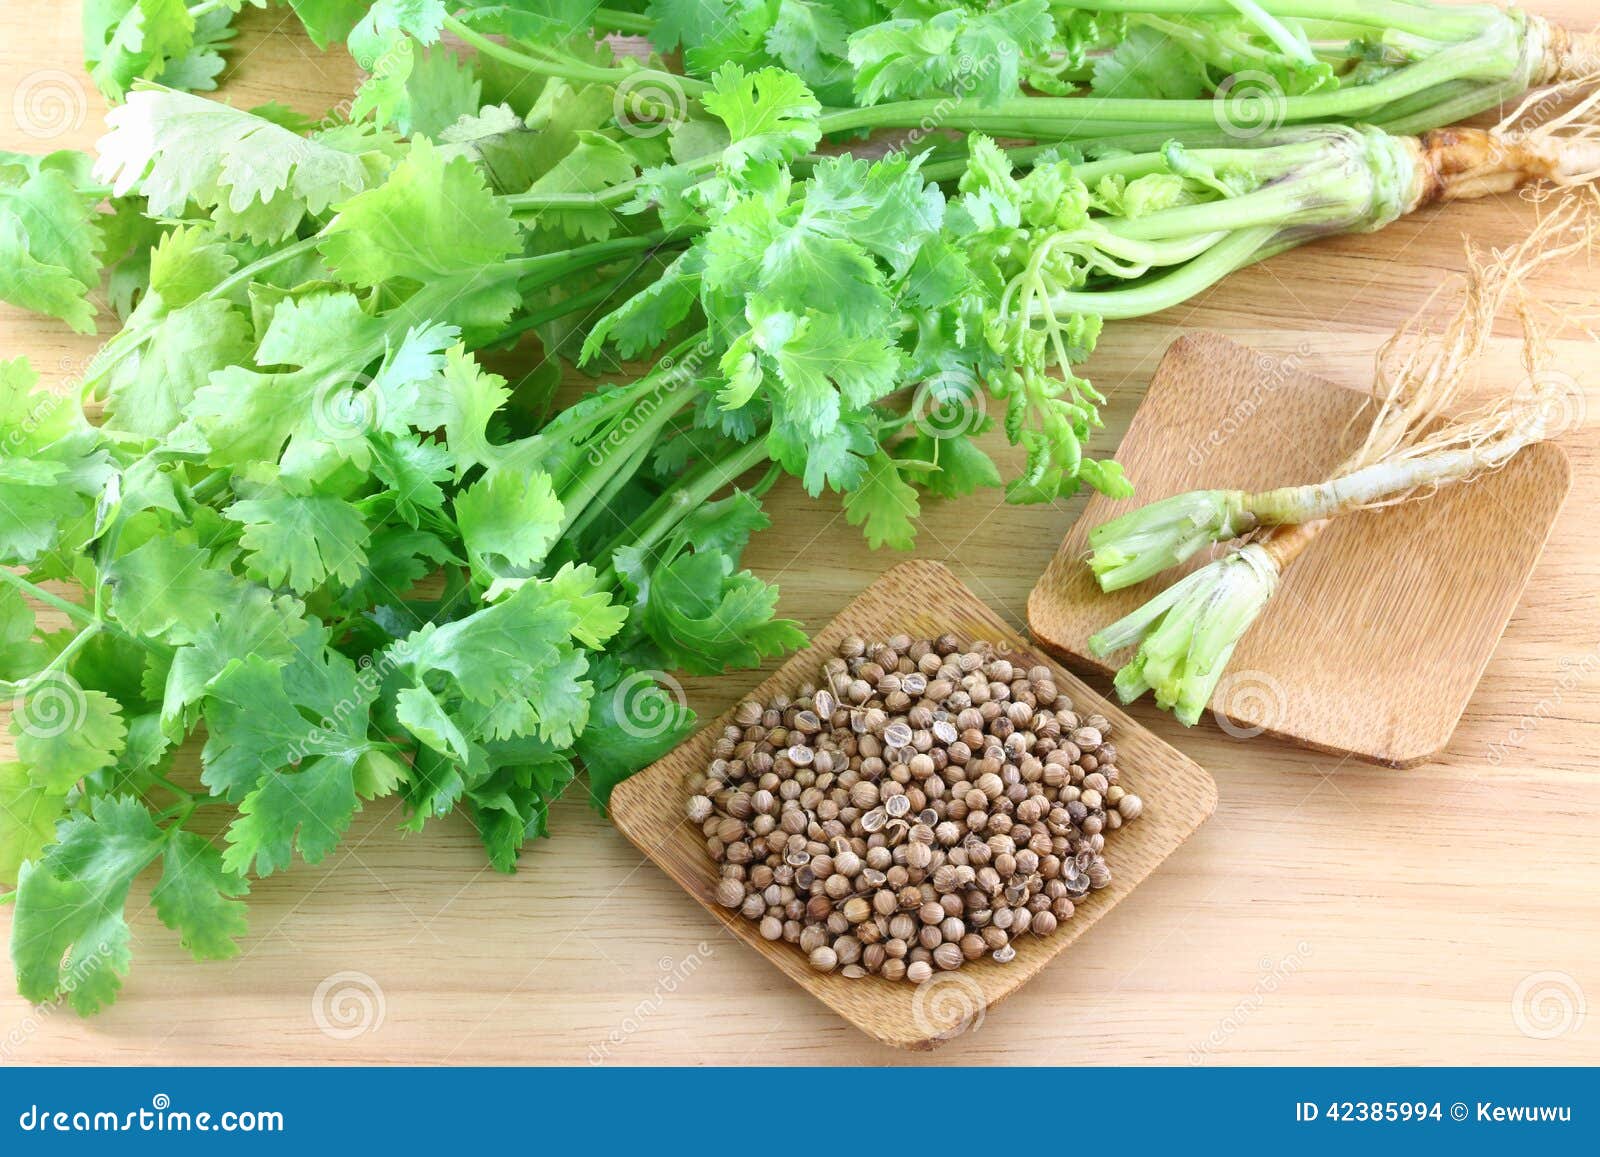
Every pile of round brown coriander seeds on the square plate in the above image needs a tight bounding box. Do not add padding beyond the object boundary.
[688,634,1141,984]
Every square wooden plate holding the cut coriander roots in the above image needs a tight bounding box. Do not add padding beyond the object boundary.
[1027,334,1571,767]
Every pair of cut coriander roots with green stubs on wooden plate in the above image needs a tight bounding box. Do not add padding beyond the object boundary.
[1090,197,1597,725]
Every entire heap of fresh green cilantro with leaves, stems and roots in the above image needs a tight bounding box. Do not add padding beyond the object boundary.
[0,0,1600,1013]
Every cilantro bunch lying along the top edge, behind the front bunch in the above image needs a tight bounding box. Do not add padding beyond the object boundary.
[212,0,1587,141]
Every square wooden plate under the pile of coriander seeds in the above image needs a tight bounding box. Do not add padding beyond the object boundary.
[611,562,1216,1048]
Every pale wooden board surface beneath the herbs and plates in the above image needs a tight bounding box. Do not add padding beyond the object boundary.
[0,0,1600,1064]
